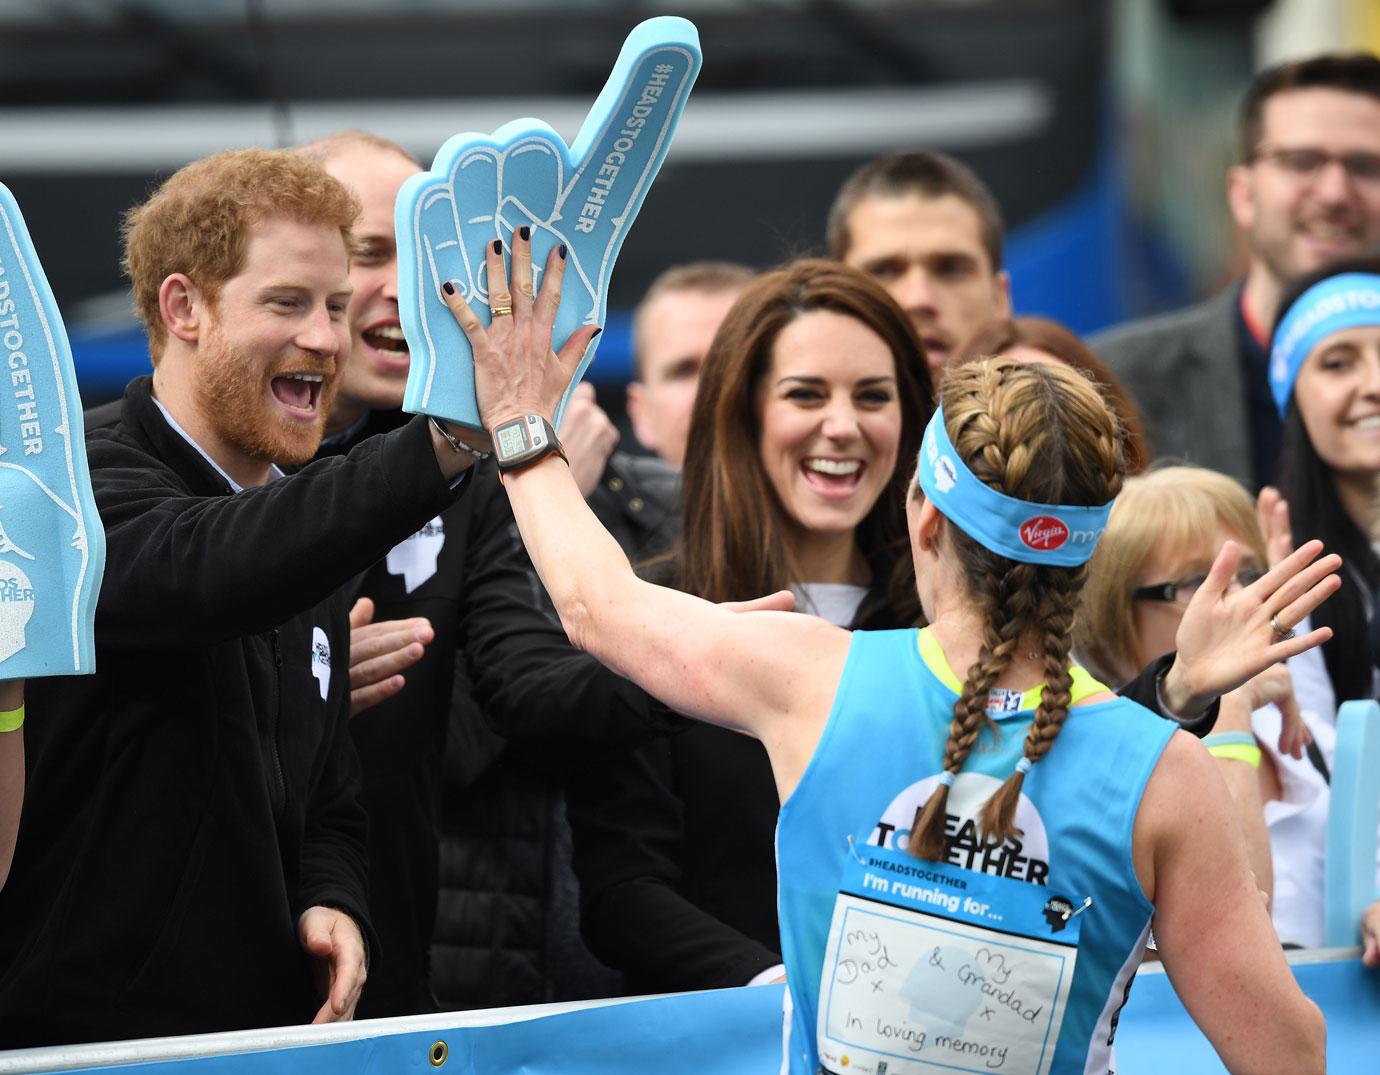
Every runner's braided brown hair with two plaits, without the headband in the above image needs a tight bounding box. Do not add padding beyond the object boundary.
[908,359,1123,860]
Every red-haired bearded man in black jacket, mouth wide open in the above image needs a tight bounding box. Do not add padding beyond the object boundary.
[0,150,488,1047]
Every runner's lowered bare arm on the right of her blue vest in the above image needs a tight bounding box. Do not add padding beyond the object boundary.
[1134,731,1326,1075]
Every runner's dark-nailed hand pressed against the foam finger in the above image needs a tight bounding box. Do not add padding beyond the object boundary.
[442,228,603,431]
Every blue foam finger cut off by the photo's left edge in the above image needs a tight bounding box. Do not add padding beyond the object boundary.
[0,185,105,679]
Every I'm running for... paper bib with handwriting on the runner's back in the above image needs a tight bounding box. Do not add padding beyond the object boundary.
[817,847,1079,1075]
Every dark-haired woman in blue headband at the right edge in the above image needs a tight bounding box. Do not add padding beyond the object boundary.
[1270,258,1380,704]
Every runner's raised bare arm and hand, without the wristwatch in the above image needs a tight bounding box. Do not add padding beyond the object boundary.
[443,235,849,792]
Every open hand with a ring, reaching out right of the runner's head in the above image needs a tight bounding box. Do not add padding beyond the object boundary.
[1165,541,1341,713]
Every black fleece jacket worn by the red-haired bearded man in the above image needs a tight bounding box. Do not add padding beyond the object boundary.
[0,377,457,1047]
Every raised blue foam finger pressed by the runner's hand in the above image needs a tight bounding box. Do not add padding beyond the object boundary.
[395,17,700,429]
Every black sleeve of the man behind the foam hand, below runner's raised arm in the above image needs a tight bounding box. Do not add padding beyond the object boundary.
[460,465,683,753]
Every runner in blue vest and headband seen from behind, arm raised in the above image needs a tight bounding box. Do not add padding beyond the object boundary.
[450,237,1337,1075]
